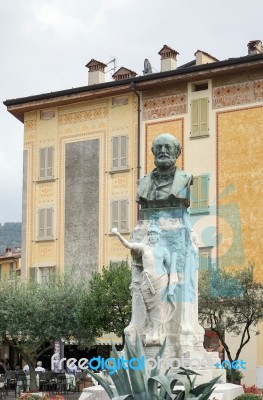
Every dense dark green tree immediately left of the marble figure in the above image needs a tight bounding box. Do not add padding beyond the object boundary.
[79,262,131,345]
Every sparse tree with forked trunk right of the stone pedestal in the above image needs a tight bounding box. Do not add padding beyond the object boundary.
[199,266,263,381]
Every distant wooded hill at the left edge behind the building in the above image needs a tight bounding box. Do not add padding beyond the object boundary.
[0,222,22,254]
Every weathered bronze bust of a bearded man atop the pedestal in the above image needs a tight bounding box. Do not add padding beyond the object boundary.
[136,133,193,208]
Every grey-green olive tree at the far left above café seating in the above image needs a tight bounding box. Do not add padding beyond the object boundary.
[0,274,88,391]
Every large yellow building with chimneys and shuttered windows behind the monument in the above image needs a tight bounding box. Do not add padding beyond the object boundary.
[5,41,263,382]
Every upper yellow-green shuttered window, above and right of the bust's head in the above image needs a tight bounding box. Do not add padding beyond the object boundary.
[191,98,209,137]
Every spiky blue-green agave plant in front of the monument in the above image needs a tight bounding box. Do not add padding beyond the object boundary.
[89,335,219,400]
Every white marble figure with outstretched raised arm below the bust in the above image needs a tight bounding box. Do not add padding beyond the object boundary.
[112,226,176,346]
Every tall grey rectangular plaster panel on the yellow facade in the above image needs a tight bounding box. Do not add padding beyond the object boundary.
[65,139,100,277]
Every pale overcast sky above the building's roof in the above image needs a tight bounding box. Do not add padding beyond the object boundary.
[0,0,263,223]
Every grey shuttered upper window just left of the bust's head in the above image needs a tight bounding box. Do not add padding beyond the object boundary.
[112,136,128,170]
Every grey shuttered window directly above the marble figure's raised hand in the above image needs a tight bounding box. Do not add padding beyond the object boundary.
[110,199,129,232]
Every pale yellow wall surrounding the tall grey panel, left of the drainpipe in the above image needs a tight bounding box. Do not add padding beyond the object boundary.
[24,94,137,276]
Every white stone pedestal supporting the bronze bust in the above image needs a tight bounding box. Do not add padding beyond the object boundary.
[125,207,226,383]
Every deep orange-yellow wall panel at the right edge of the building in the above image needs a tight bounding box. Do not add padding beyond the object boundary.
[217,107,263,280]
